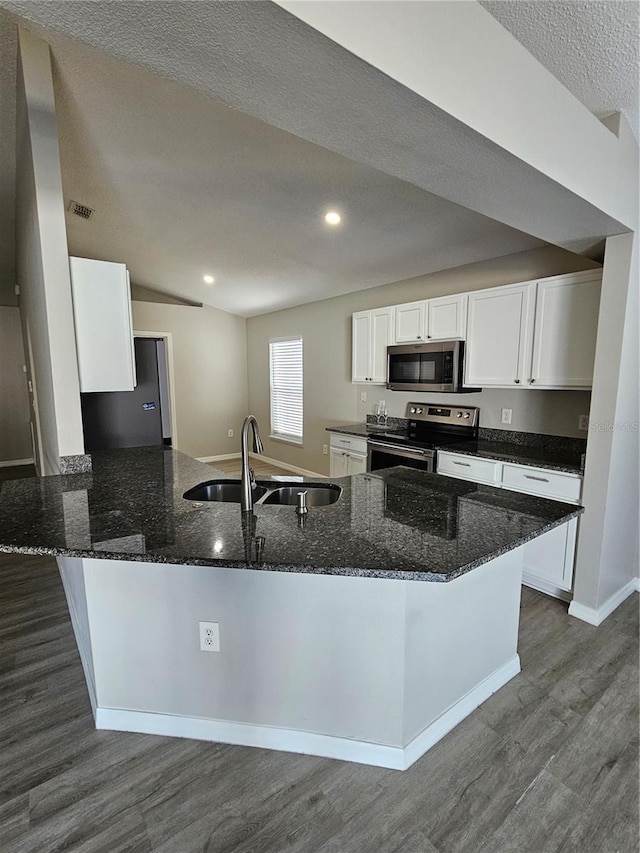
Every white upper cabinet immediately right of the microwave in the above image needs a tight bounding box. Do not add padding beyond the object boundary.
[465,284,535,388]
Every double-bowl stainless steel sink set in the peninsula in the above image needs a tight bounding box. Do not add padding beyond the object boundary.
[183,480,342,507]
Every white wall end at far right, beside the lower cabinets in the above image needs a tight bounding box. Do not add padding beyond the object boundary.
[574,234,640,608]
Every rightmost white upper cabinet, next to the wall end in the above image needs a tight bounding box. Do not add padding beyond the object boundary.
[529,272,602,388]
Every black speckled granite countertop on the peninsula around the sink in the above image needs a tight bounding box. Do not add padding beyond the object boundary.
[0,447,582,581]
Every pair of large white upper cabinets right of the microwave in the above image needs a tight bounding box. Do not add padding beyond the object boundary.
[465,271,601,389]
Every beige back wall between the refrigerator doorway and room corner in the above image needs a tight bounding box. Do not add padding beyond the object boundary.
[133,302,247,457]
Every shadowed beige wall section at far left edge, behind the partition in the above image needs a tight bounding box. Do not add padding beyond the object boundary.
[0,307,33,462]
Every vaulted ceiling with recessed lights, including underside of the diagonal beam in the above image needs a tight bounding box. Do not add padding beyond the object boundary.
[0,0,632,314]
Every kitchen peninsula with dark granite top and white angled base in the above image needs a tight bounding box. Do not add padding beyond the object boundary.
[0,447,582,769]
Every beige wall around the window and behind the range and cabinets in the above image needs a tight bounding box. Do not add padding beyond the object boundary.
[247,246,596,474]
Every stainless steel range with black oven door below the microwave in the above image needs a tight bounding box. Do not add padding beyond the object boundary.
[367,403,480,471]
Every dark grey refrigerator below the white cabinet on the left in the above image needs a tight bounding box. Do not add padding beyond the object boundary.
[80,338,171,453]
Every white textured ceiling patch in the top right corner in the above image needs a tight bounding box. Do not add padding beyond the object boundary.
[480,0,640,139]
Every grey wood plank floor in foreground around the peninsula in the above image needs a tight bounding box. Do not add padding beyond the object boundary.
[0,555,639,853]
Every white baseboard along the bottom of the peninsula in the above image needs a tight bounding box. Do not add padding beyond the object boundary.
[95,655,520,770]
